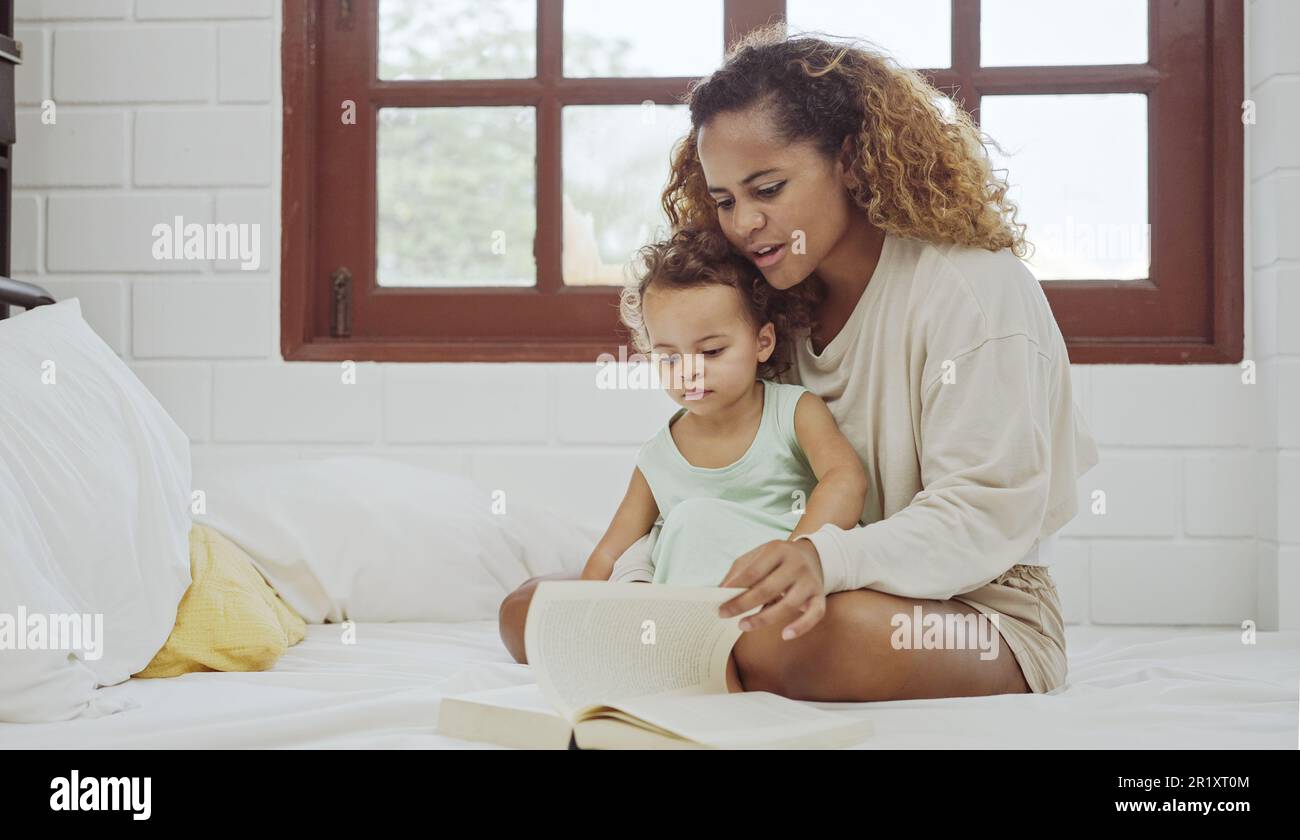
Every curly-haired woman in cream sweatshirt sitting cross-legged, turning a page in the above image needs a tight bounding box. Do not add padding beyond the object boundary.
[501,26,1097,701]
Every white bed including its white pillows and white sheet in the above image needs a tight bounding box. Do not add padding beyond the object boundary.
[0,283,1300,749]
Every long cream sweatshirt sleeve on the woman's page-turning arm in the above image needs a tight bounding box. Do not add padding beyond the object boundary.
[800,334,1053,599]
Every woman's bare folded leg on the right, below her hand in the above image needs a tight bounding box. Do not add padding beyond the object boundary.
[732,589,1030,702]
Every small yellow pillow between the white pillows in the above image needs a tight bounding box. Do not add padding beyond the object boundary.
[135,525,307,677]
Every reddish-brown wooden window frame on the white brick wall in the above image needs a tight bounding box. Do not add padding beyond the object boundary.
[281,0,1244,363]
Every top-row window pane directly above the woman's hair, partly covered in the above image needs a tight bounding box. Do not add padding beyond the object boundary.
[785,0,953,69]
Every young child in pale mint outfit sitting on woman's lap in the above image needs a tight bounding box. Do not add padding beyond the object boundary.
[582,230,866,586]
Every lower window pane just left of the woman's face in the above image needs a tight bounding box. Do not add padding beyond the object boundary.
[563,103,690,286]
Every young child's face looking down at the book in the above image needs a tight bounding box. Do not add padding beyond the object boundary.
[642,286,776,415]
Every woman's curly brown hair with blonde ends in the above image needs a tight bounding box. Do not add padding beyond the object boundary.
[662,22,1028,256]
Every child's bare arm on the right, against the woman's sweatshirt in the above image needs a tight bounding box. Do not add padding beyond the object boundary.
[789,393,867,540]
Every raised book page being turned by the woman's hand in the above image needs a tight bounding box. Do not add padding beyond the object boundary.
[524,580,759,720]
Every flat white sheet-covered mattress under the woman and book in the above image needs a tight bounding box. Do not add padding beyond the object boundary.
[0,622,1300,749]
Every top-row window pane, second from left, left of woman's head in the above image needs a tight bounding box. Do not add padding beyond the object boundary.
[564,0,723,77]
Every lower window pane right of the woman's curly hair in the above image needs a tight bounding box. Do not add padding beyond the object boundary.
[980,94,1151,280]
